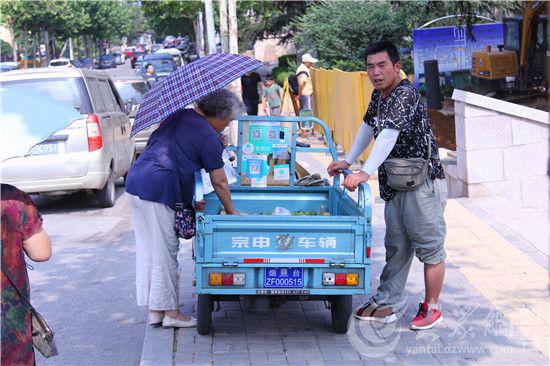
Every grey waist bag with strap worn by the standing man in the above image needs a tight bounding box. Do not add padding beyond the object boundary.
[376,96,432,191]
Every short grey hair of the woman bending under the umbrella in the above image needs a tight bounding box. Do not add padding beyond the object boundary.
[197,89,244,121]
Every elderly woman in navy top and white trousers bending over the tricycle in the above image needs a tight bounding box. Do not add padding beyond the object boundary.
[126,89,242,328]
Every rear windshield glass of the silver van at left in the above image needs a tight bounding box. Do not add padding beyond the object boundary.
[2,77,92,114]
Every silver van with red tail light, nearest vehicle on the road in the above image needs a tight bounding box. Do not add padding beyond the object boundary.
[0,68,135,207]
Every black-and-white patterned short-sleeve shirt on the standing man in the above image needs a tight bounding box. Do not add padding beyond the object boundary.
[363,79,445,202]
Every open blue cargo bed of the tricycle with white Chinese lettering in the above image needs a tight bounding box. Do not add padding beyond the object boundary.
[195,187,370,264]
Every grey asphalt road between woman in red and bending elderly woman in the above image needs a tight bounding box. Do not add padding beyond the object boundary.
[29,61,147,365]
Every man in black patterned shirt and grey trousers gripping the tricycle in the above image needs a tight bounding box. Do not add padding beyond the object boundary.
[328,41,447,330]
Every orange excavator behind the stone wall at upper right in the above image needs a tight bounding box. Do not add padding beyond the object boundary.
[470,1,548,90]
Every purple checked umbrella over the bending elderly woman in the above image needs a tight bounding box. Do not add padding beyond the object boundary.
[131,53,262,135]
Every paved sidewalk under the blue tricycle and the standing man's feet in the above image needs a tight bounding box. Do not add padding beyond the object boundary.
[141,133,550,365]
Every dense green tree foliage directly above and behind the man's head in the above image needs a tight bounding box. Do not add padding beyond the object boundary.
[294,0,522,69]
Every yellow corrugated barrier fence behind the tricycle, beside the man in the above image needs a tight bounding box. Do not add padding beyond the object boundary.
[311,68,406,161]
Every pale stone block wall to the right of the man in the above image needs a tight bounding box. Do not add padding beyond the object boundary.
[446,89,550,208]
